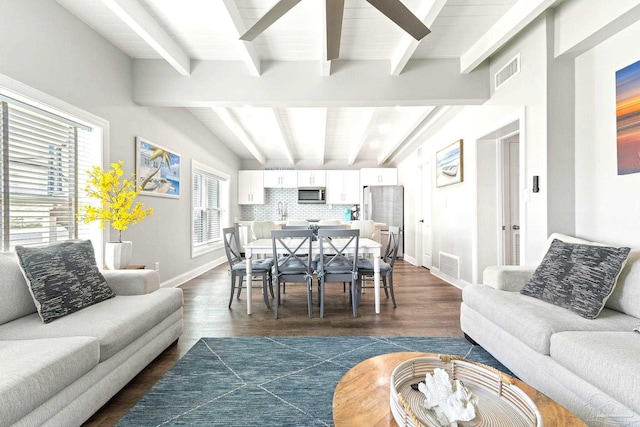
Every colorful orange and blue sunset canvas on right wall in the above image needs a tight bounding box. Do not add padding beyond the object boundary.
[616,61,640,175]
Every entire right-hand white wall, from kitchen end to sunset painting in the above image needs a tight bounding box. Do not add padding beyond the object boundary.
[400,0,640,284]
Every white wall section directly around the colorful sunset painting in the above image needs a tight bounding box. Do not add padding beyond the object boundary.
[575,22,640,248]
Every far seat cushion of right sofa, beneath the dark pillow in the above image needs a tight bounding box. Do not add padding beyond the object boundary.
[462,285,638,355]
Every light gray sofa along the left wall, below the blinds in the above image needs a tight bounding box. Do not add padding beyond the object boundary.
[0,253,183,427]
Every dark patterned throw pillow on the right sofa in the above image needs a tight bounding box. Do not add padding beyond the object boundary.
[521,239,630,319]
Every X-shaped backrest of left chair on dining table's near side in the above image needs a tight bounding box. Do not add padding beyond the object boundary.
[271,228,314,276]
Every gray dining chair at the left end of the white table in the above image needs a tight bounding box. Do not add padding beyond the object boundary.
[222,227,273,308]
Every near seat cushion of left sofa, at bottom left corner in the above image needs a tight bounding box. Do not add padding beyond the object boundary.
[0,338,100,426]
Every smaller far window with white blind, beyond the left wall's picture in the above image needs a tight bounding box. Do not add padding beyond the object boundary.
[193,167,225,247]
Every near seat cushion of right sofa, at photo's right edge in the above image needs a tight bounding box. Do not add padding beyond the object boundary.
[551,332,640,412]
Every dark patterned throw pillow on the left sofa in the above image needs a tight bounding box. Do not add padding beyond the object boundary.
[16,240,115,323]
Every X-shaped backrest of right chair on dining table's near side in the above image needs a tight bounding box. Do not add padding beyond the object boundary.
[317,228,360,275]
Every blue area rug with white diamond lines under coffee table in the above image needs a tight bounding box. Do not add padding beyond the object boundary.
[118,337,510,427]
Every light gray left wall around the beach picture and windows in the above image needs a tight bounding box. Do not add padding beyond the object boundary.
[0,0,240,288]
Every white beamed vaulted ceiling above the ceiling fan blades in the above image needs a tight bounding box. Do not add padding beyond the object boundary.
[57,0,557,168]
